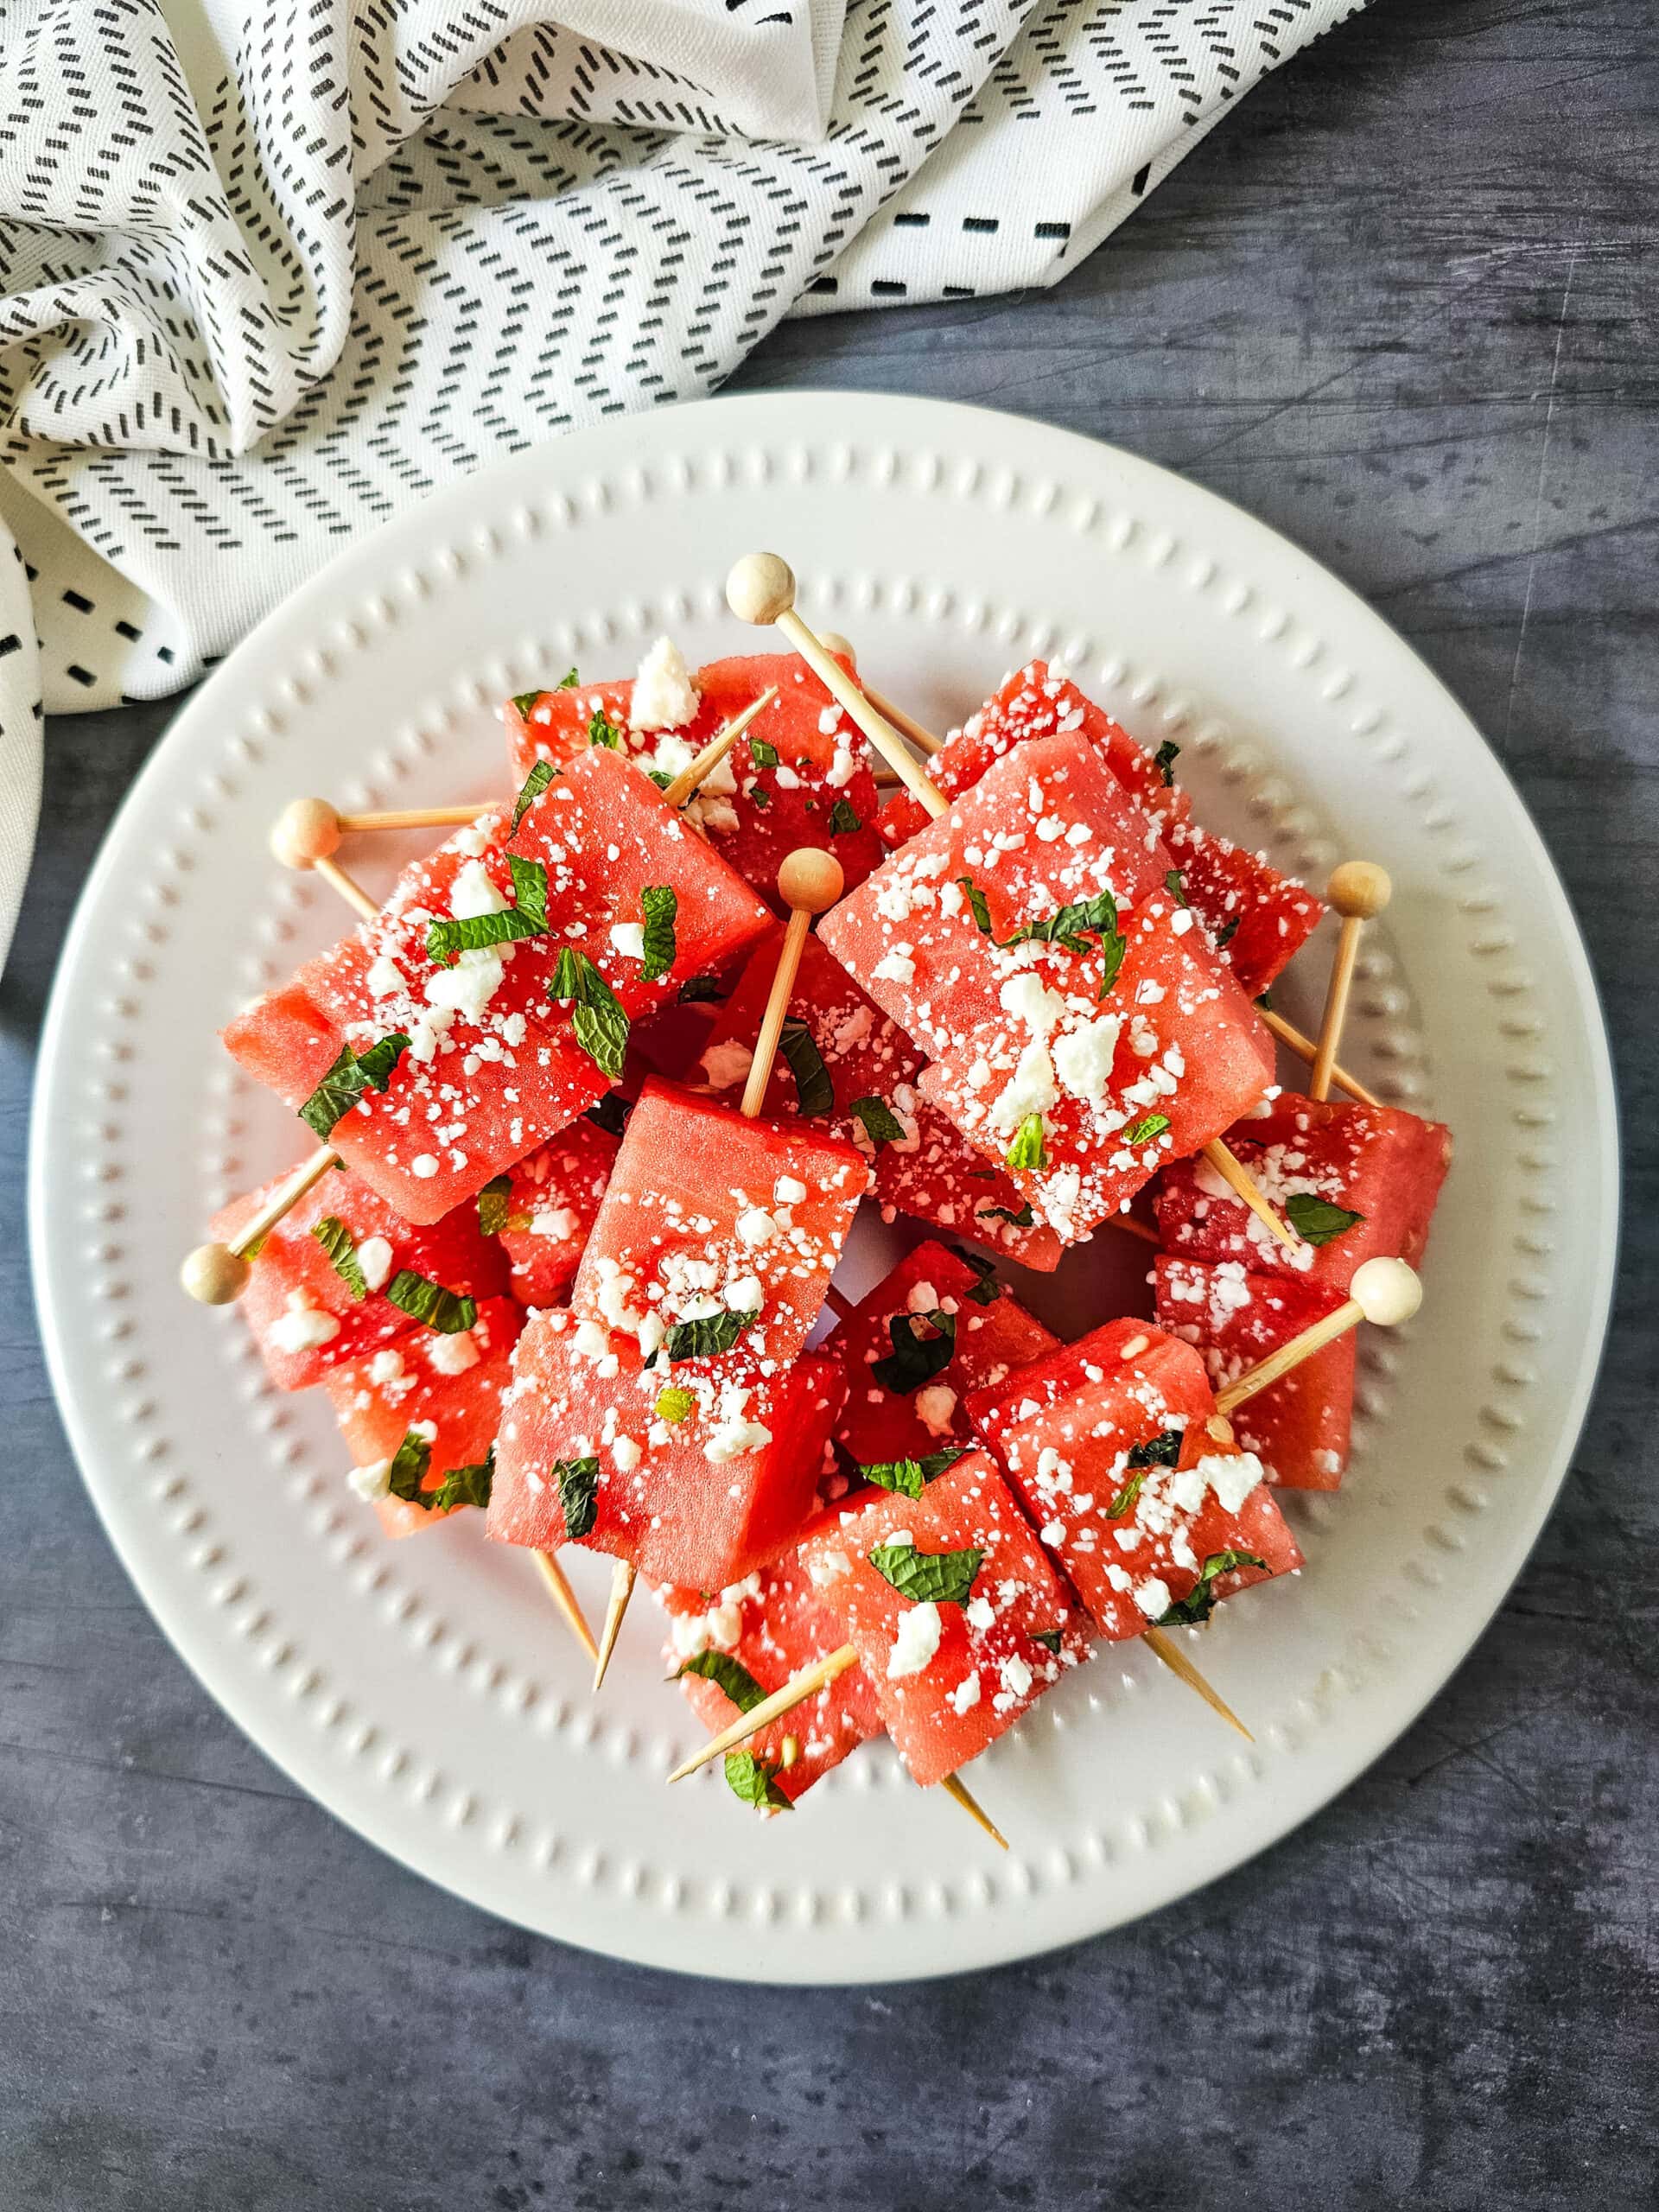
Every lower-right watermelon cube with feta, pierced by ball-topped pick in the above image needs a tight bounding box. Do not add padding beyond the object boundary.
[973,1320,1303,1642]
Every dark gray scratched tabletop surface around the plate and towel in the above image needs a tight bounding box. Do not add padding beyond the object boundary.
[0,0,1659,2212]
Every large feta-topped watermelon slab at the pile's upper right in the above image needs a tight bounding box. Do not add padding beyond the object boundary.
[821,732,1272,1243]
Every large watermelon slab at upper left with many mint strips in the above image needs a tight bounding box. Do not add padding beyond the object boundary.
[224,747,767,1224]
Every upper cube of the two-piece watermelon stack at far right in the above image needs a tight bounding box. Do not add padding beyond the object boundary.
[1157,1090,1451,1292]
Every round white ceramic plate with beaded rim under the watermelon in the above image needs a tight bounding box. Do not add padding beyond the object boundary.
[31,394,1617,1982]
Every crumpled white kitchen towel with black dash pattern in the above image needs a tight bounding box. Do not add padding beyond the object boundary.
[0,0,1360,942]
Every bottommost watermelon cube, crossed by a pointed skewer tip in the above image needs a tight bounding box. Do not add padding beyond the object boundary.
[657,1553,882,1802]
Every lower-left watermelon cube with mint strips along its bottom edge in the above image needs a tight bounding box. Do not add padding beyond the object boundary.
[323,1299,524,1535]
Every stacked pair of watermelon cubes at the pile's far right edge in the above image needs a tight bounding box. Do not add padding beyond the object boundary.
[1154,1090,1451,1491]
